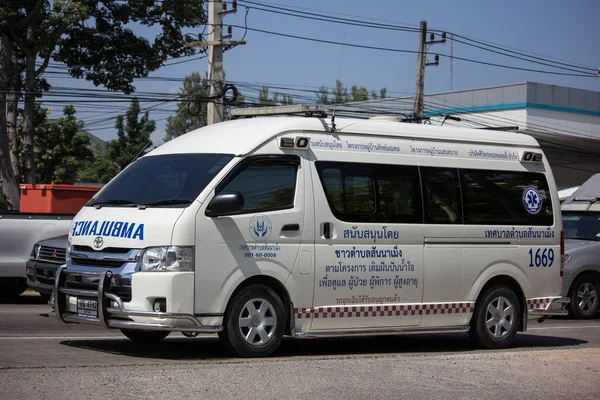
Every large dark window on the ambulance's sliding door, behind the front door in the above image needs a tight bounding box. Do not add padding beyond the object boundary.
[316,161,423,223]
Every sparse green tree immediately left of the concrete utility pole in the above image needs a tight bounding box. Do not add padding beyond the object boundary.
[163,72,210,142]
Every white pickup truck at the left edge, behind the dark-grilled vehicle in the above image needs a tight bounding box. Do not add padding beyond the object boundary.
[0,211,73,300]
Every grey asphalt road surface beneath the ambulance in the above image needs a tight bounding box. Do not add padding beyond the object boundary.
[0,295,600,400]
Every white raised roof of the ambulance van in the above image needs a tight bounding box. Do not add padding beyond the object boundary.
[148,117,539,155]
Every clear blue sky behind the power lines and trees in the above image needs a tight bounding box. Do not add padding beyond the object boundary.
[42,0,600,144]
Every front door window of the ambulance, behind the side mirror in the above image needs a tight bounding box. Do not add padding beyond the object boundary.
[217,160,298,213]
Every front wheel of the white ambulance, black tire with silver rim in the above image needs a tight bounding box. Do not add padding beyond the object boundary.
[219,285,286,357]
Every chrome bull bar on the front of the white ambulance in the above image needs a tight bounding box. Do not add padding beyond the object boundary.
[54,266,223,333]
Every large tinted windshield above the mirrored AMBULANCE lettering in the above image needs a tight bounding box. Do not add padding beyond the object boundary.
[86,154,233,207]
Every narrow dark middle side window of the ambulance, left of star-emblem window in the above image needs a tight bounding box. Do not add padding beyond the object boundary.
[421,167,463,224]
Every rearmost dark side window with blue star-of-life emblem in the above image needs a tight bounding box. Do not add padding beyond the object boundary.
[460,169,554,226]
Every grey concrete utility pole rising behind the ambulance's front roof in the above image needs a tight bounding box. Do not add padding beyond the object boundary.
[187,0,246,125]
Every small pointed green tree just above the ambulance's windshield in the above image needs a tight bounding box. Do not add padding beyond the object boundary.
[108,97,156,170]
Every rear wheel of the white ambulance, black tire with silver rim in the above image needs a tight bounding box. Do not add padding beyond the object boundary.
[469,285,522,349]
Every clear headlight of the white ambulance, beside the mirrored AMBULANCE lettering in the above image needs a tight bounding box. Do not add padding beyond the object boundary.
[141,246,194,272]
